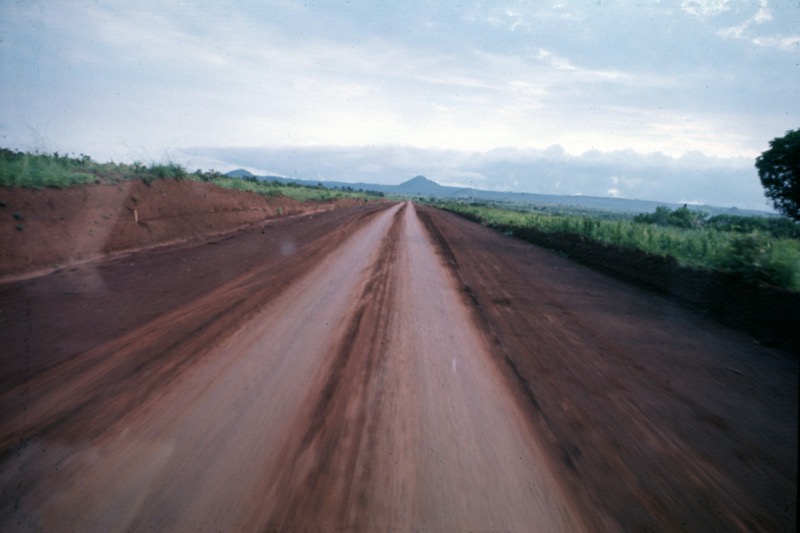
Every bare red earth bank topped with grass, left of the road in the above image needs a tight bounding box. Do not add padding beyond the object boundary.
[0,180,376,279]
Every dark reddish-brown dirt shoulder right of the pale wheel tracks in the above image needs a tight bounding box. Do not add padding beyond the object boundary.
[420,208,798,531]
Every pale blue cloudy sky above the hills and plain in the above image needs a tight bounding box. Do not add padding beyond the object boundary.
[0,0,800,209]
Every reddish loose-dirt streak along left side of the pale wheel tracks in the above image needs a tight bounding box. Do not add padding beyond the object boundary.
[0,206,390,462]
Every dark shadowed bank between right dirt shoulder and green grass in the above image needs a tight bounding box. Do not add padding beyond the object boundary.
[434,204,800,354]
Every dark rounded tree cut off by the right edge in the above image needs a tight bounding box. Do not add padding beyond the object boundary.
[756,129,800,220]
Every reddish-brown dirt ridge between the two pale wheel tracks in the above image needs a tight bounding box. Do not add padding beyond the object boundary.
[266,204,406,531]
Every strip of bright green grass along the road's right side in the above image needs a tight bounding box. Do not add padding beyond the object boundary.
[436,202,800,291]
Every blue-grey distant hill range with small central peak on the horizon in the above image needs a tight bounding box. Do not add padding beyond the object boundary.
[226,169,775,216]
